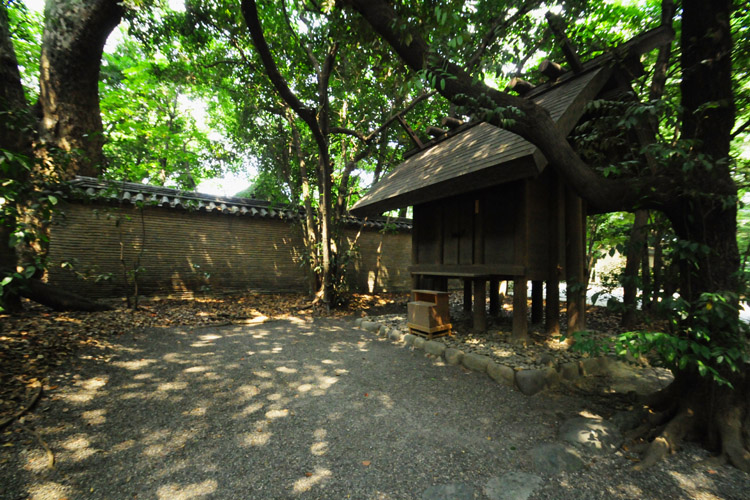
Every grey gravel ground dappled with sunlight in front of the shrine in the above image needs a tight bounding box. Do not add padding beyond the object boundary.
[0,318,750,500]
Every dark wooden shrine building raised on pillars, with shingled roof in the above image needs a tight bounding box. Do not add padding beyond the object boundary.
[352,28,671,341]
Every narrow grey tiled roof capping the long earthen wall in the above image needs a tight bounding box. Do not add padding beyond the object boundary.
[70,176,412,230]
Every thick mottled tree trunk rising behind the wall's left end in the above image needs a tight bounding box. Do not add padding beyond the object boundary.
[39,0,123,177]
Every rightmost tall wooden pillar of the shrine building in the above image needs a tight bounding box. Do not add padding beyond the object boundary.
[565,189,586,334]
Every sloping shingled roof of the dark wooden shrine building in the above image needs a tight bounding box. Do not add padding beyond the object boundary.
[351,27,672,216]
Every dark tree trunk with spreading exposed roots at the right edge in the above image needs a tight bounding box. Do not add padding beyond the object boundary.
[641,0,750,472]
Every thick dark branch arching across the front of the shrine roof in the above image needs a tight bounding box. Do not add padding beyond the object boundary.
[349,0,672,211]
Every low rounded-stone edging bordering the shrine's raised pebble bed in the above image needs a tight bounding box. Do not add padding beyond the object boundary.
[354,318,620,396]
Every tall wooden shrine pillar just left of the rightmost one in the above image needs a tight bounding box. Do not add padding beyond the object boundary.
[544,176,565,336]
